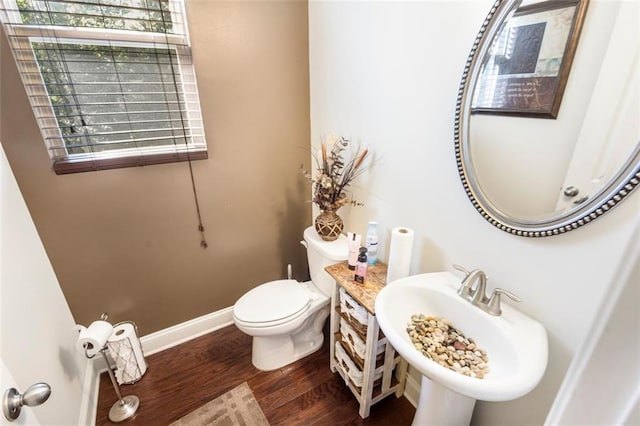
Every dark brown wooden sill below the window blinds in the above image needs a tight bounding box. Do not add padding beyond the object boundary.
[53,151,208,175]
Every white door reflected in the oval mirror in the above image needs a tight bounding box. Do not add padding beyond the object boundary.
[557,2,640,210]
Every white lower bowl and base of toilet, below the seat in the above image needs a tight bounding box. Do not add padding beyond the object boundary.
[251,306,330,371]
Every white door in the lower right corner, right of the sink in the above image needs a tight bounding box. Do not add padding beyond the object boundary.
[545,216,640,426]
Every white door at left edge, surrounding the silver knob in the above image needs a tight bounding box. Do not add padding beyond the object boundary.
[0,145,89,425]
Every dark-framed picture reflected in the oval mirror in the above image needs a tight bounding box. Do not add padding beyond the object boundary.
[471,0,588,118]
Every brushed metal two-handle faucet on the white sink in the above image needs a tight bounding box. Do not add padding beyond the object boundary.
[453,265,521,316]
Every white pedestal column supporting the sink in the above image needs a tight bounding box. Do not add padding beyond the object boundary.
[412,376,476,426]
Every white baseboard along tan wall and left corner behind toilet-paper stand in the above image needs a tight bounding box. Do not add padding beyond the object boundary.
[78,307,233,426]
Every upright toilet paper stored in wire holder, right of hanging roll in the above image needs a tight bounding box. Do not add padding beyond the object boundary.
[107,322,147,385]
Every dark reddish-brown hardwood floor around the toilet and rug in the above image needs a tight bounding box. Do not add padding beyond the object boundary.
[96,325,415,426]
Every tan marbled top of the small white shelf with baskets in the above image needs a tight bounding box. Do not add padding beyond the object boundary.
[324,261,387,315]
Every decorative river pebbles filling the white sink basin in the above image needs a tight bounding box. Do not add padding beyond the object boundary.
[407,314,489,379]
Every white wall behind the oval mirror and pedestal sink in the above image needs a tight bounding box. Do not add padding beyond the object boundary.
[309,0,640,425]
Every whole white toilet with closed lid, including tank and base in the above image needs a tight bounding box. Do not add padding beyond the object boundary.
[233,227,348,371]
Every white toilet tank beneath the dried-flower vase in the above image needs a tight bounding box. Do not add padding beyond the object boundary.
[304,226,349,296]
